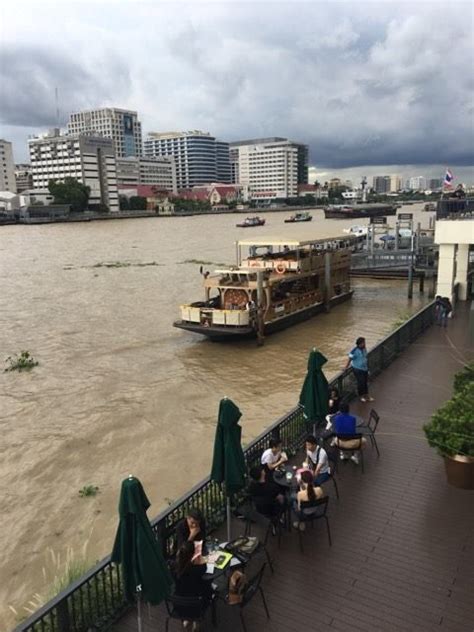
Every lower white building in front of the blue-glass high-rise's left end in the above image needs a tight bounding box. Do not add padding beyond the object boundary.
[116,156,178,193]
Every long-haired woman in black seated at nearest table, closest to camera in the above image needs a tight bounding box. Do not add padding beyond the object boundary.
[173,541,213,630]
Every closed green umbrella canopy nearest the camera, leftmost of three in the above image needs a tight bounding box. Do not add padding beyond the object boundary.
[112,476,172,605]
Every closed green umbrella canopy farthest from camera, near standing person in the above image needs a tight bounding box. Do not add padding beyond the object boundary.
[300,349,329,423]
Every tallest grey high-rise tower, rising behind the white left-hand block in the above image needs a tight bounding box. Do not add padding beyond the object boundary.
[67,108,142,158]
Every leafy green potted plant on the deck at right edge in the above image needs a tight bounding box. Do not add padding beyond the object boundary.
[423,364,474,489]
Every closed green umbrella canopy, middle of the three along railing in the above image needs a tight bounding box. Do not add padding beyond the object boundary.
[211,398,246,495]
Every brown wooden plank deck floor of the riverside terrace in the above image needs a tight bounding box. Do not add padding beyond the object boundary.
[113,309,474,632]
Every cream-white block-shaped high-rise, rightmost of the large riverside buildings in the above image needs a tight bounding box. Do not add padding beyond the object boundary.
[230,136,308,200]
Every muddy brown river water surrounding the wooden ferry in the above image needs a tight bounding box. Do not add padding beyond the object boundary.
[0,205,430,629]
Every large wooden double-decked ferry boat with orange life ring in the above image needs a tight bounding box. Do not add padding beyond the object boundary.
[173,236,353,340]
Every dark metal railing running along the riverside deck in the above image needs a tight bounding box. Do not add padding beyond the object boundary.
[15,302,434,632]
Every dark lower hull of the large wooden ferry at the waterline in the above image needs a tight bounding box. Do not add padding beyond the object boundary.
[173,290,354,342]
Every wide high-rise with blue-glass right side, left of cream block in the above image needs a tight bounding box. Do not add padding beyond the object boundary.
[144,130,231,189]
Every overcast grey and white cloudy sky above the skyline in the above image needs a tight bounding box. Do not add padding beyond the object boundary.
[0,0,474,181]
